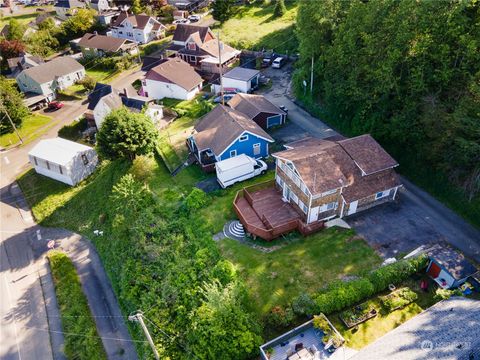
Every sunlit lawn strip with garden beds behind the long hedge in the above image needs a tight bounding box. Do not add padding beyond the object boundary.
[329,279,437,350]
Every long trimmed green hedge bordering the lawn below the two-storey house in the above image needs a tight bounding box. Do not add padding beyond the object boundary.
[292,256,428,315]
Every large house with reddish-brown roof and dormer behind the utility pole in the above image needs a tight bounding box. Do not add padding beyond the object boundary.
[166,24,240,74]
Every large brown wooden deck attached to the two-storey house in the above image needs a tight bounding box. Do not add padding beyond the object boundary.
[234,181,323,240]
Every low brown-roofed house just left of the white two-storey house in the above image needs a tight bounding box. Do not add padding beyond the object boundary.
[78,33,138,57]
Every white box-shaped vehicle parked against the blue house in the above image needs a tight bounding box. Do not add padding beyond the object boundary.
[215,154,267,189]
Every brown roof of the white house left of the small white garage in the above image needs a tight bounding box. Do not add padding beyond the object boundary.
[145,57,203,91]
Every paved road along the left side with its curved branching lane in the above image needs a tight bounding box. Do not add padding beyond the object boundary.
[0,70,144,360]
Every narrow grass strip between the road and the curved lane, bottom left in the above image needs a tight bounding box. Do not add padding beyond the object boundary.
[48,251,107,360]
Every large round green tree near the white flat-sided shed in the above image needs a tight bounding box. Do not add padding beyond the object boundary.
[97,107,158,160]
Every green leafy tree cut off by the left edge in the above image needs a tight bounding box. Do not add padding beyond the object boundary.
[0,76,30,134]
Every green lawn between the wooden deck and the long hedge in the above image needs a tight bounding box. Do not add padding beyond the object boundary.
[220,228,381,315]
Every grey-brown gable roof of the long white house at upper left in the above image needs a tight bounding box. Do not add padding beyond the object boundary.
[23,56,85,84]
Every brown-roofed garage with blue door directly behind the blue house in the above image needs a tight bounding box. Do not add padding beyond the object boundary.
[228,93,287,130]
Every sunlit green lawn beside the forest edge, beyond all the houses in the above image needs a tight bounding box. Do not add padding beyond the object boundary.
[214,3,298,54]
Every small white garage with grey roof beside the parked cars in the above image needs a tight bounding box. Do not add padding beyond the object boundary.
[212,66,260,93]
